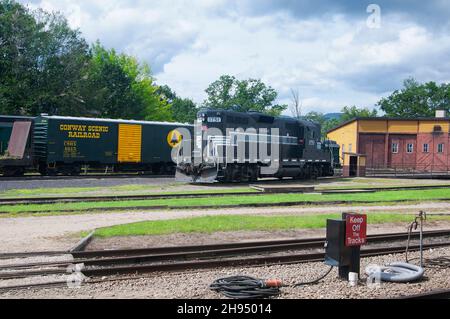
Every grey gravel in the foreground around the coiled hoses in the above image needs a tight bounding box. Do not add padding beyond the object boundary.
[0,248,450,299]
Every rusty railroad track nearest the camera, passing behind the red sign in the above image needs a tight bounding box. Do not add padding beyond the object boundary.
[0,230,450,291]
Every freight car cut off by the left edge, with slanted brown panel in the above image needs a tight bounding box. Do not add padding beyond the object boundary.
[0,115,34,176]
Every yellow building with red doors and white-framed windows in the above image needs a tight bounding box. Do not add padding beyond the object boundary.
[327,117,450,176]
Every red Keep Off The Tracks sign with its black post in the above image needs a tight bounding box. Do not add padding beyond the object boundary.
[339,213,367,280]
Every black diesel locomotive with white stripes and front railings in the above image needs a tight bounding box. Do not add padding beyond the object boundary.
[176,110,339,183]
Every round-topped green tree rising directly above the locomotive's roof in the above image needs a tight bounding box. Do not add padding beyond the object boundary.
[203,75,287,116]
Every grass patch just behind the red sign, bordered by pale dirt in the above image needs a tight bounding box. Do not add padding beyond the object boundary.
[90,213,450,238]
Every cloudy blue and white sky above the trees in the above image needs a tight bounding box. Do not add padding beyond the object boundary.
[20,0,450,112]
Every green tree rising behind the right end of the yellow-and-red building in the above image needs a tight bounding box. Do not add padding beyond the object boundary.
[377,78,450,118]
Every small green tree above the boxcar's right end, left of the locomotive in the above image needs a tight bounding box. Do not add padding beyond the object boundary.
[158,85,198,123]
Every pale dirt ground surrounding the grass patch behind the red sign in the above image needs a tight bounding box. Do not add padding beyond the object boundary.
[0,203,450,253]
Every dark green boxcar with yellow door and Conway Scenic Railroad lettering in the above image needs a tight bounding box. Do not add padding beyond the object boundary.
[33,116,193,175]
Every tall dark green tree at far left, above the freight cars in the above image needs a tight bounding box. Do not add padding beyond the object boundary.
[0,0,89,115]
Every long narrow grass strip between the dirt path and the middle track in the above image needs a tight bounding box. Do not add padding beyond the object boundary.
[4,188,450,213]
